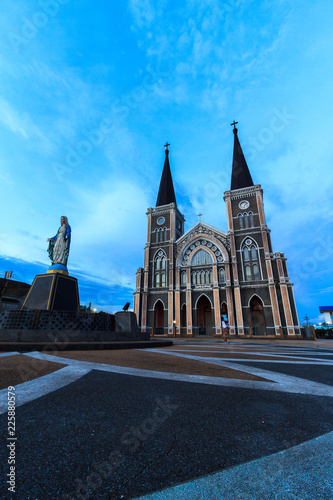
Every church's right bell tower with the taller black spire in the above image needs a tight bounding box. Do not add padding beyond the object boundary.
[224,121,298,336]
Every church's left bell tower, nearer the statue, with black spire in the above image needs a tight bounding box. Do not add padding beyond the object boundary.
[134,143,185,334]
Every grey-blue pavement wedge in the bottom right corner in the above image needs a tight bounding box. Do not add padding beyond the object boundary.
[135,432,333,500]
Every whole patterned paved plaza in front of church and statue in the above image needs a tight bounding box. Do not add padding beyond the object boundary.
[0,339,333,500]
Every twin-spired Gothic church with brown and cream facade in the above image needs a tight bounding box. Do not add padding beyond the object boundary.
[134,123,301,337]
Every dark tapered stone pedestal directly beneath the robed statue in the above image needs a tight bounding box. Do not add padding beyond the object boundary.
[22,271,80,311]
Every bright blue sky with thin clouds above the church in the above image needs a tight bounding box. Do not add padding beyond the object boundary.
[0,0,333,322]
